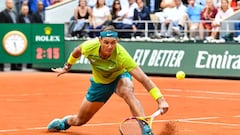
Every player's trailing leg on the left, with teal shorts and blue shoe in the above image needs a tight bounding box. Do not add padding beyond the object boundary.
[48,79,114,132]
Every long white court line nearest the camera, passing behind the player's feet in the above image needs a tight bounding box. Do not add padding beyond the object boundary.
[0,117,219,133]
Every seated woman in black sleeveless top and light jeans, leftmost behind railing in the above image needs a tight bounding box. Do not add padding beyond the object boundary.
[69,0,92,37]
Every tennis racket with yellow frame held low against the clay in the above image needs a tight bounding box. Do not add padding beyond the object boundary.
[119,109,163,135]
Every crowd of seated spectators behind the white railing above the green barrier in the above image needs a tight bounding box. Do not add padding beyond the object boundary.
[67,0,240,40]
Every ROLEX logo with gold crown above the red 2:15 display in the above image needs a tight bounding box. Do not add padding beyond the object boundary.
[35,26,61,42]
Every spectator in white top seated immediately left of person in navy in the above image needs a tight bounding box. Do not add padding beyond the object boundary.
[118,0,138,38]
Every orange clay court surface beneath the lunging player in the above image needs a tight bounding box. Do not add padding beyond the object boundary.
[0,72,240,135]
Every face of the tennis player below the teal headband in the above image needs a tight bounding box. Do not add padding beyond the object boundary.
[99,37,118,57]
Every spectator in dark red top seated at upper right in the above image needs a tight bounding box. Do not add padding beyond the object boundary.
[199,0,218,40]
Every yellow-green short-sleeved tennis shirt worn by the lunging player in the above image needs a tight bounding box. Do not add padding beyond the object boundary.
[80,39,137,84]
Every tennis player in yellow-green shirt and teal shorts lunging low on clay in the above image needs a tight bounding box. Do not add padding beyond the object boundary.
[48,26,168,134]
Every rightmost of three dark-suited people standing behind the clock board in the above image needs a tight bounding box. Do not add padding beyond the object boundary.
[32,1,45,23]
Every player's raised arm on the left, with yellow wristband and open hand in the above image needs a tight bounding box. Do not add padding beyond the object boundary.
[51,46,81,76]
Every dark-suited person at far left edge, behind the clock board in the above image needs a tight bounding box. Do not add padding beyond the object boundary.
[0,0,22,71]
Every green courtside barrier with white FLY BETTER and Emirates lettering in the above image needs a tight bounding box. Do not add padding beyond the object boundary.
[38,41,240,77]
